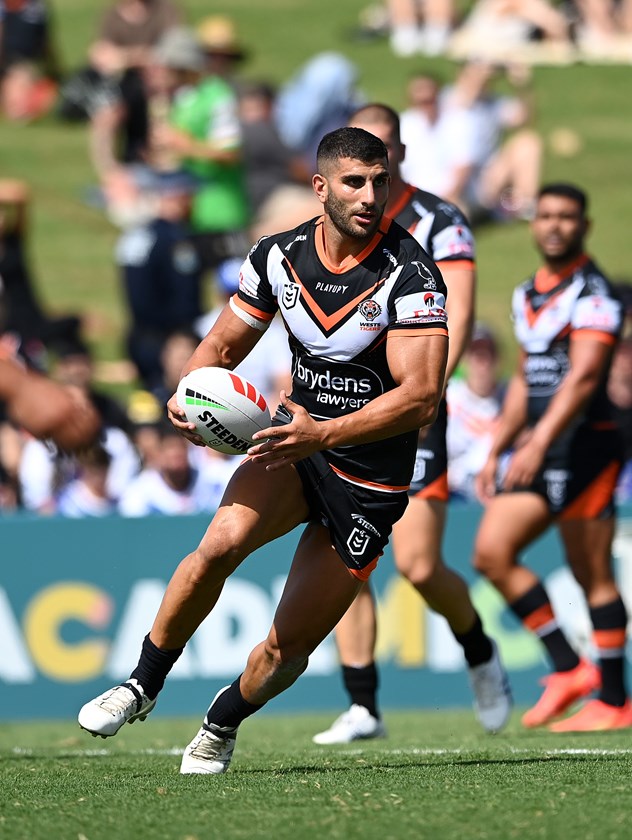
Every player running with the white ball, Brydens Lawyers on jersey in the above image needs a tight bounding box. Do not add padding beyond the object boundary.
[79,128,448,774]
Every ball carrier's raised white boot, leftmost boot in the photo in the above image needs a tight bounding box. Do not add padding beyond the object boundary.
[78,679,156,738]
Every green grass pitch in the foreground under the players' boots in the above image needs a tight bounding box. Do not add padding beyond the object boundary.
[0,711,632,840]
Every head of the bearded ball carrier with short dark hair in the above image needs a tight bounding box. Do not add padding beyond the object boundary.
[312,127,390,240]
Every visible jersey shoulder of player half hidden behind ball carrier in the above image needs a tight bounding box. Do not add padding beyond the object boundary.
[389,184,476,267]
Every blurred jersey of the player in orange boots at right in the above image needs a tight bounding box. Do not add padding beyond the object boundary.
[512,254,622,440]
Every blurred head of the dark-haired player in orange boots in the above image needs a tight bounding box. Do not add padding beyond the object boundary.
[531,182,590,264]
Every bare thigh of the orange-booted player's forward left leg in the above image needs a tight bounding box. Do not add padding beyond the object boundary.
[474,493,553,574]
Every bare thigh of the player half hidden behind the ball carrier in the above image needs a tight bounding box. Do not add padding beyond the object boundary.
[392,496,447,575]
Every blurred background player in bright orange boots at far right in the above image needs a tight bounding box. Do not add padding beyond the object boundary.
[474,184,632,732]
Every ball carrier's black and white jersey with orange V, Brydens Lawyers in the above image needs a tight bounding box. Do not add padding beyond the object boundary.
[231,217,447,492]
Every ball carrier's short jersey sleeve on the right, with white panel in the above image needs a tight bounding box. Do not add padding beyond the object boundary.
[389,255,448,335]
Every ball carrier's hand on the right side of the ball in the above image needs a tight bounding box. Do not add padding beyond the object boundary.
[248,391,323,471]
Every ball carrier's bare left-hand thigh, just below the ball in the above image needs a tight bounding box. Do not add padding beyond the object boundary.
[199,460,309,566]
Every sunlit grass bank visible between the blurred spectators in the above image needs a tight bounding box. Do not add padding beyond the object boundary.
[0,0,632,382]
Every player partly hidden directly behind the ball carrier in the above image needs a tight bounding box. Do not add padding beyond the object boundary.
[314,104,511,744]
